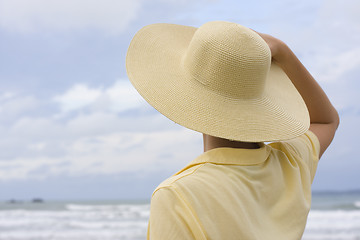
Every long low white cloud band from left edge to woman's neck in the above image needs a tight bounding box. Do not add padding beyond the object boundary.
[0,129,201,181]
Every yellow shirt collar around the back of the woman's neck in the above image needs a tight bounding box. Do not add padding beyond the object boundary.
[178,143,270,173]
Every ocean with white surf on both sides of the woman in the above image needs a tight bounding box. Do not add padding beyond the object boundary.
[0,192,360,240]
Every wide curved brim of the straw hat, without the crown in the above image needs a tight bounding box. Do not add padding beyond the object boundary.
[126,23,310,142]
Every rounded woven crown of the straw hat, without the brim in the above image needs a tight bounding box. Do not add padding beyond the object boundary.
[184,22,271,99]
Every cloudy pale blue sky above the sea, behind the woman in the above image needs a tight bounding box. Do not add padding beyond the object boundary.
[0,0,360,200]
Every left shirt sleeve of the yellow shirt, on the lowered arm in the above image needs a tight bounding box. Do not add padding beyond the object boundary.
[147,187,206,240]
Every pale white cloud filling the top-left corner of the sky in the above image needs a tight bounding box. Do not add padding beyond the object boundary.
[0,0,140,34]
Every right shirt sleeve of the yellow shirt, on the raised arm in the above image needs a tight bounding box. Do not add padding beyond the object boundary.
[285,130,320,181]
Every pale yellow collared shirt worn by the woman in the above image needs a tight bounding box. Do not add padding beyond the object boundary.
[148,131,320,240]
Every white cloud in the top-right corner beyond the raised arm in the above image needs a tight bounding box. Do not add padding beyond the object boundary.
[303,0,360,82]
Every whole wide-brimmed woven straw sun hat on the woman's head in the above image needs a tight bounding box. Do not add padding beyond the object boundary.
[126,21,310,142]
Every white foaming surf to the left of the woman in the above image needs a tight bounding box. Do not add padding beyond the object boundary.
[0,204,150,240]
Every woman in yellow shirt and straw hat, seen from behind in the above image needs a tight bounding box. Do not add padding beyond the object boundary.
[126,21,339,240]
